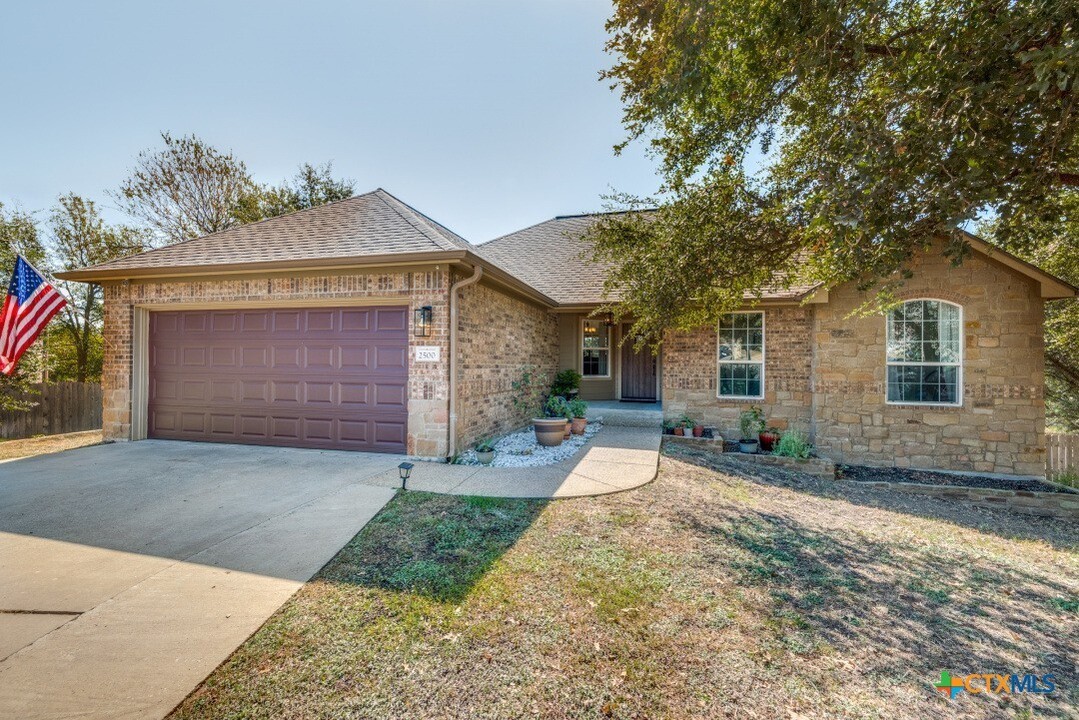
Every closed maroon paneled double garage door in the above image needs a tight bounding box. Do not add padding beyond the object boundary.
[149,308,408,452]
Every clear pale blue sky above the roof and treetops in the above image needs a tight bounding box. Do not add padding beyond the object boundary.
[0,0,658,242]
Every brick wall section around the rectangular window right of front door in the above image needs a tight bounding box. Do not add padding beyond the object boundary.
[663,305,814,439]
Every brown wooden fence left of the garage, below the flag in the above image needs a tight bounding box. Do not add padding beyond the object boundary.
[0,382,101,440]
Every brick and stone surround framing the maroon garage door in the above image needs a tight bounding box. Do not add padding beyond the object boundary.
[101,270,449,457]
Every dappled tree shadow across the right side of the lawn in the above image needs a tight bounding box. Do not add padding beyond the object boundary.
[677,452,1079,717]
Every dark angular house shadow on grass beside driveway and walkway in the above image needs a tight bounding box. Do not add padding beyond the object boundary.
[318,491,549,603]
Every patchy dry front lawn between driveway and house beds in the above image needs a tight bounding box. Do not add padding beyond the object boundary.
[174,449,1079,718]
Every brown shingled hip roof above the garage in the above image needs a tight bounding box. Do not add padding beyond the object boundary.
[71,188,472,270]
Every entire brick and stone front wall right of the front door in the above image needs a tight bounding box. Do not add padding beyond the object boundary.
[663,252,1044,475]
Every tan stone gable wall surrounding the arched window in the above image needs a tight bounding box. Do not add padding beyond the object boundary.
[814,250,1046,475]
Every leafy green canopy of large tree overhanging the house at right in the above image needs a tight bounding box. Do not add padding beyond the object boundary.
[592,0,1079,344]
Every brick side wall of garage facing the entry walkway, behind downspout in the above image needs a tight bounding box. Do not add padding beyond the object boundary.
[457,283,559,450]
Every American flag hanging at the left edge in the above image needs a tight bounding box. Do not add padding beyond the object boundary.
[0,255,67,375]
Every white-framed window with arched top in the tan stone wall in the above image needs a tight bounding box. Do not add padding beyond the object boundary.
[887,300,962,405]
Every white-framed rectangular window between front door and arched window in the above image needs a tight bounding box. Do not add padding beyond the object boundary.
[716,312,764,399]
